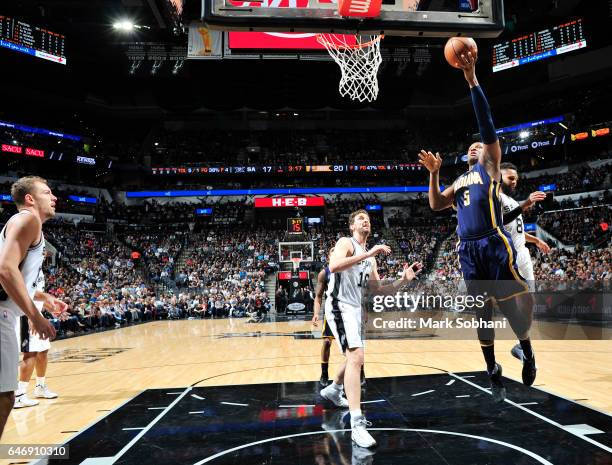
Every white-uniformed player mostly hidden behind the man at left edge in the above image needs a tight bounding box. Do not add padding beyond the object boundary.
[14,270,68,408]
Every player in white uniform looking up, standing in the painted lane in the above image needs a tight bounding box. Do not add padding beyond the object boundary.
[321,210,422,447]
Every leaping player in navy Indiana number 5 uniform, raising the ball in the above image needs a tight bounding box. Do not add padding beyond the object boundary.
[419,52,536,401]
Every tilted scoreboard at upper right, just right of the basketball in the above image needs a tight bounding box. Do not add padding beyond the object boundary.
[493,19,587,73]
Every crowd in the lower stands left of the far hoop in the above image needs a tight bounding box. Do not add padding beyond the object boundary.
[35,221,271,336]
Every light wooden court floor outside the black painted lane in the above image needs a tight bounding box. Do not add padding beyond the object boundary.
[0,319,612,463]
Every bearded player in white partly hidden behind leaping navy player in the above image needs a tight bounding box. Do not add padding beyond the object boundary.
[500,163,550,286]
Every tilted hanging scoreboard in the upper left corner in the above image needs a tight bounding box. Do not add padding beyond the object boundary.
[0,15,66,65]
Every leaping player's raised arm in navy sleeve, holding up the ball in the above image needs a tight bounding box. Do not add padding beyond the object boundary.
[460,51,501,171]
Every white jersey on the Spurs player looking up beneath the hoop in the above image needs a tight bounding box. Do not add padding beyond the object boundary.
[327,237,374,308]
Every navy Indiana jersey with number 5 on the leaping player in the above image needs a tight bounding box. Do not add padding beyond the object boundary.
[453,163,503,240]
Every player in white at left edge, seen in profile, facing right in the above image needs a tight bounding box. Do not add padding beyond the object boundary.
[0,176,57,437]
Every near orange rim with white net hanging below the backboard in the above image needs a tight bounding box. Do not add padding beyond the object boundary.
[317,34,383,102]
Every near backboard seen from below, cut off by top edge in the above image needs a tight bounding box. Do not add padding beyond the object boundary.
[202,0,504,37]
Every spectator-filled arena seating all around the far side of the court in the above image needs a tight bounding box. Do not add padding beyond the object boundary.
[0,147,612,336]
